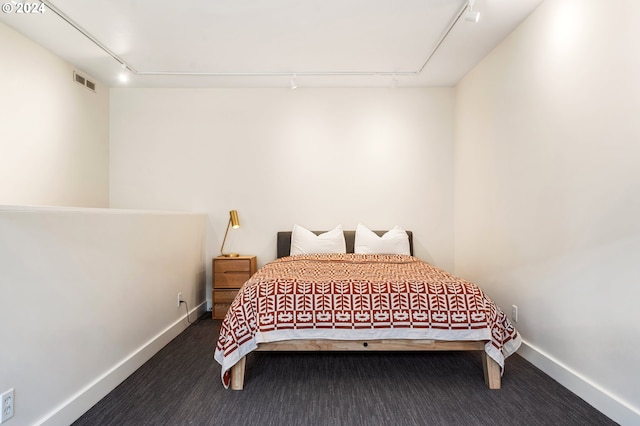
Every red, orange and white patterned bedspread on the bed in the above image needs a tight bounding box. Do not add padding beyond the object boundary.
[214,254,521,387]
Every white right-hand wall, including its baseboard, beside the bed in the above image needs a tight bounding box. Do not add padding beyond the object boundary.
[455,0,640,424]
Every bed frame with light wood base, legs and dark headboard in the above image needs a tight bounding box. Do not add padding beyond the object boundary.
[231,231,501,390]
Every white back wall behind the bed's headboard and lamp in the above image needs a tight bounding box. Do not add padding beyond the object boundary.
[110,88,454,298]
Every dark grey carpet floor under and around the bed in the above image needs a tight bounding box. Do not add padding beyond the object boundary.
[74,314,616,426]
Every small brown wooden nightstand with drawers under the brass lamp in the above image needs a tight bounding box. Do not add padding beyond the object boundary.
[211,256,257,319]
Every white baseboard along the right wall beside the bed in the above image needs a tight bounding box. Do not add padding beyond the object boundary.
[518,341,640,425]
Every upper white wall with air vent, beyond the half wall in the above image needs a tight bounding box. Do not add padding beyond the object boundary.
[0,23,109,207]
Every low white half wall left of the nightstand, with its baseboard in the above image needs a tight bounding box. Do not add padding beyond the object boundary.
[0,206,206,426]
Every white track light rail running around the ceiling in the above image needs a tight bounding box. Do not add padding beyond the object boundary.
[41,0,479,83]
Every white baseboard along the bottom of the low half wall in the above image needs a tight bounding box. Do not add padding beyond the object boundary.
[37,301,207,426]
